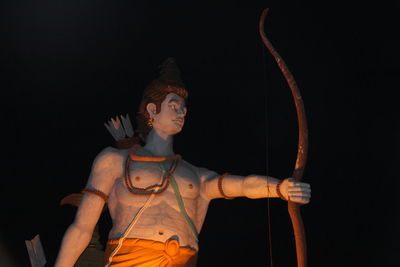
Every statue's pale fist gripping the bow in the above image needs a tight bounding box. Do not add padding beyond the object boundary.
[280,178,311,204]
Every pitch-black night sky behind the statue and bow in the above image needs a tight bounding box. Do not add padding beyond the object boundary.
[0,0,400,267]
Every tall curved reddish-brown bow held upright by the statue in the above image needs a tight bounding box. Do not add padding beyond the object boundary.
[259,8,308,267]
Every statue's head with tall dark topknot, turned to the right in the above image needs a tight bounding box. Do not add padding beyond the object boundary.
[136,58,188,141]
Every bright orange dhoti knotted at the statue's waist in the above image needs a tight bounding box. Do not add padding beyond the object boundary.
[105,238,197,267]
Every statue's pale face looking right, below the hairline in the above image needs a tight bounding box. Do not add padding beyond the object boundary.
[149,93,187,135]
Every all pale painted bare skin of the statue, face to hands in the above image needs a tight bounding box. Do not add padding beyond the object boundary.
[55,93,311,267]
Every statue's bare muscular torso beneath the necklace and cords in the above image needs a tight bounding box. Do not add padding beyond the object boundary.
[108,156,209,250]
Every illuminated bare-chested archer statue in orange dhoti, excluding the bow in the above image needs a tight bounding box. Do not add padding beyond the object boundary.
[55,58,311,267]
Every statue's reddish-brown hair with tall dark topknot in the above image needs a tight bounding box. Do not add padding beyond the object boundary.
[136,58,189,142]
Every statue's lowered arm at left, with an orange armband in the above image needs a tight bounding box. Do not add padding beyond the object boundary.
[55,148,124,267]
